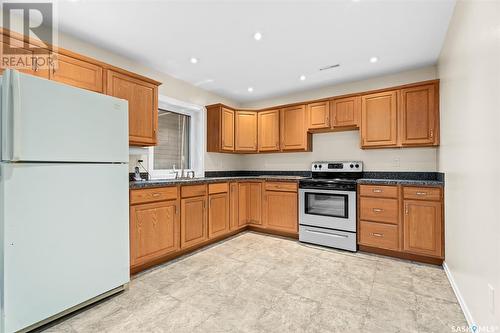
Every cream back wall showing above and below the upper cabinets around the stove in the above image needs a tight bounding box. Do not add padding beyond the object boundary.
[238,66,437,171]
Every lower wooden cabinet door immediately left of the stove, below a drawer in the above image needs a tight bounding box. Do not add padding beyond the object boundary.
[263,191,298,233]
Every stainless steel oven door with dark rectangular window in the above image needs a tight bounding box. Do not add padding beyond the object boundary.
[299,188,356,232]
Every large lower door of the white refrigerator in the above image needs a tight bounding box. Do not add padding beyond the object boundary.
[0,163,129,332]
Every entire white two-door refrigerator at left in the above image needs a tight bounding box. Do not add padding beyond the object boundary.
[0,70,129,333]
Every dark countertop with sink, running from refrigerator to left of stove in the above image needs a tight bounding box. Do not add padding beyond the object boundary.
[129,175,304,189]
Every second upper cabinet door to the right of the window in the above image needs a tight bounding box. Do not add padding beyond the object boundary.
[234,111,257,151]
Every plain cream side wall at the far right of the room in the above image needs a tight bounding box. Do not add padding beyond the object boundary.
[438,1,500,329]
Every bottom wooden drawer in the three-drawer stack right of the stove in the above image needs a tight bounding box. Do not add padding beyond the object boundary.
[359,221,399,250]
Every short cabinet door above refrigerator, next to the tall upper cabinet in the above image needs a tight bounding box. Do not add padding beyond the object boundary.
[49,54,103,92]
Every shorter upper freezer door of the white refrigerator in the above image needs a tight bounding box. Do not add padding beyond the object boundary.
[0,70,128,162]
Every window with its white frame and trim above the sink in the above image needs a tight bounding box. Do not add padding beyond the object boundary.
[147,95,206,179]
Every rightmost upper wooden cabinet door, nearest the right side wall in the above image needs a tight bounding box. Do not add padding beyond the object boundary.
[400,84,438,145]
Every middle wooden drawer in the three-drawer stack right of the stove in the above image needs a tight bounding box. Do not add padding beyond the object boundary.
[359,197,398,224]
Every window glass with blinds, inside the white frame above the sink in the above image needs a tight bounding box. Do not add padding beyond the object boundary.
[153,110,191,170]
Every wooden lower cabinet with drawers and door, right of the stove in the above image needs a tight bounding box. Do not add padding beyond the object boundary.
[358,185,444,263]
